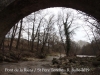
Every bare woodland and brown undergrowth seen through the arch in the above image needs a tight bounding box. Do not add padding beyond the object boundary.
[0,9,100,61]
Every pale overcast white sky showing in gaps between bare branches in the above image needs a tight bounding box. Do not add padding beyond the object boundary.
[19,7,93,42]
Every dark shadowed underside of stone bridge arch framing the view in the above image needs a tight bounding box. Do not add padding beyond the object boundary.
[0,0,100,43]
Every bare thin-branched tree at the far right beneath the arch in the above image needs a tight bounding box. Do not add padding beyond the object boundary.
[82,15,100,54]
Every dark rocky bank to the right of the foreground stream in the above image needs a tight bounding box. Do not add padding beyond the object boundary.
[52,56,100,75]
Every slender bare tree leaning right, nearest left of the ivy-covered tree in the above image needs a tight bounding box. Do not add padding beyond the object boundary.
[40,15,55,57]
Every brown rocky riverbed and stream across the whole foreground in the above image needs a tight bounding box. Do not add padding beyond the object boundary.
[0,55,100,75]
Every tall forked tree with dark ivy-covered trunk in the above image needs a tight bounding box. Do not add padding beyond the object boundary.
[58,10,78,56]
